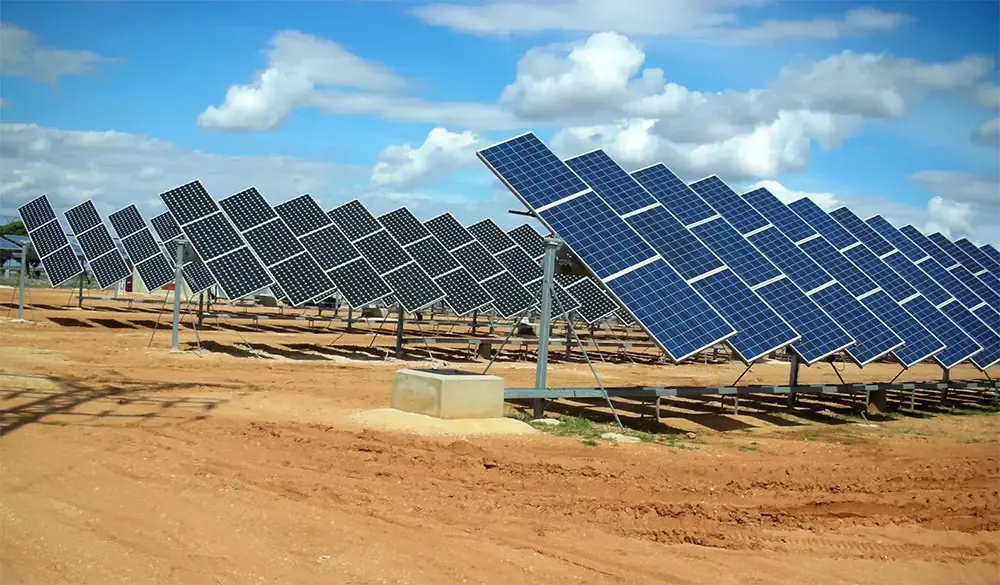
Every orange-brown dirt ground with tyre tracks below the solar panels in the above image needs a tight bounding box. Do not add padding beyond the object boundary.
[0,289,1000,585]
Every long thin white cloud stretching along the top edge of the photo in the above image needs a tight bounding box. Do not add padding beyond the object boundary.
[413,0,912,43]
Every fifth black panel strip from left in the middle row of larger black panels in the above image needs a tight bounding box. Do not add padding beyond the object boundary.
[378,207,493,316]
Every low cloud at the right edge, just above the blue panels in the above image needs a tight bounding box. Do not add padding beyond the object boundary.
[910,171,1000,243]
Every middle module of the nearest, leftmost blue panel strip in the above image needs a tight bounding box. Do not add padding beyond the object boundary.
[539,192,656,280]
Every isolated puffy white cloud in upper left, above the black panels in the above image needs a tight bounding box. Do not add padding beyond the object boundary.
[198,30,406,130]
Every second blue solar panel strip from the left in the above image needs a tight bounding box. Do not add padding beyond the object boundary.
[566,150,800,363]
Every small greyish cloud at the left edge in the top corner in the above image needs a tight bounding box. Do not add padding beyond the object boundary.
[0,21,120,83]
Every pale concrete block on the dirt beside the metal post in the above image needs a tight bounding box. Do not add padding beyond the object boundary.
[390,369,504,419]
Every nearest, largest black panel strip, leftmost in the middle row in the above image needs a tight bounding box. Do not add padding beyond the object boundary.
[162,181,274,301]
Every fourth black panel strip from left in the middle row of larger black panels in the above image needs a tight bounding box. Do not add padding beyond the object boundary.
[329,199,445,313]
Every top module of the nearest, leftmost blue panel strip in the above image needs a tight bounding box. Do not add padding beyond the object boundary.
[476,132,587,209]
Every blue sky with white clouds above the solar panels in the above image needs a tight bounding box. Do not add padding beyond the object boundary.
[0,0,1000,244]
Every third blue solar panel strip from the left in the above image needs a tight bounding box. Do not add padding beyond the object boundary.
[632,165,854,364]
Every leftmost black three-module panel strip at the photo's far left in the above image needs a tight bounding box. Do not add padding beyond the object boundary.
[17,195,83,286]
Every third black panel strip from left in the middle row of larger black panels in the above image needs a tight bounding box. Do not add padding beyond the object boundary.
[274,194,392,309]
